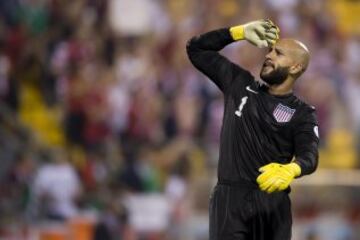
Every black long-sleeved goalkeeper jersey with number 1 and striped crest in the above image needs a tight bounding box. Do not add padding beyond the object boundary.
[187,29,319,182]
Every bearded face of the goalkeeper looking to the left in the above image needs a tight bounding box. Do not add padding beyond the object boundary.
[260,45,291,85]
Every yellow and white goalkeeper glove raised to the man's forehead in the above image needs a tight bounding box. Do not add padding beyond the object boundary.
[230,20,280,48]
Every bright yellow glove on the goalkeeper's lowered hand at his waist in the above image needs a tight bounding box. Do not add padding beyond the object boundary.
[256,162,301,193]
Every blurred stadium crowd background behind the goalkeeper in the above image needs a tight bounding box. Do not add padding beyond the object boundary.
[0,0,360,240]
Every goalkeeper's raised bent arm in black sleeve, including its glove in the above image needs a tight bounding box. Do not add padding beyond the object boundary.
[186,20,278,92]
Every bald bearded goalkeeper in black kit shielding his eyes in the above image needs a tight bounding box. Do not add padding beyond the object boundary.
[187,20,319,240]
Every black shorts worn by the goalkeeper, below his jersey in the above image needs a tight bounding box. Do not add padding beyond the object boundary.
[209,182,292,240]
